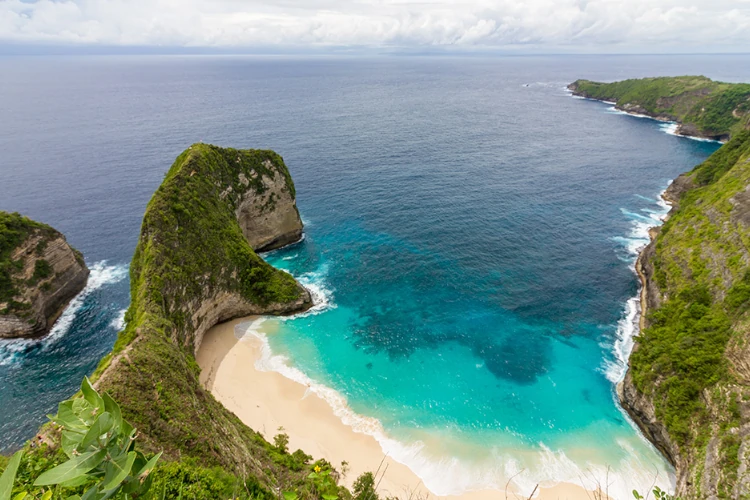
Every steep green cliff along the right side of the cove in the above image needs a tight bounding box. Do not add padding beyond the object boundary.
[618,132,750,499]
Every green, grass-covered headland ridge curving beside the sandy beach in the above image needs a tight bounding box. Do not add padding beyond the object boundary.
[94,144,312,491]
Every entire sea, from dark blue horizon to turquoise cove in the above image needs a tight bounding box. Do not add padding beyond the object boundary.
[0,55,750,495]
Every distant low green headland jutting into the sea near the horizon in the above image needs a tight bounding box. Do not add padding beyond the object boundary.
[568,76,750,141]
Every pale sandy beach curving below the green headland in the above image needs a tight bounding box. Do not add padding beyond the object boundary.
[196,317,612,500]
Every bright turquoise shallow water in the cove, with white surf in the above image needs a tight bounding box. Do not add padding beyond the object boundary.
[264,183,670,494]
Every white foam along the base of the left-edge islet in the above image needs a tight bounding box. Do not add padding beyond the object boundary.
[0,260,128,365]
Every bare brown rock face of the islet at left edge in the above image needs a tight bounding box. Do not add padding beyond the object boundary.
[0,229,89,338]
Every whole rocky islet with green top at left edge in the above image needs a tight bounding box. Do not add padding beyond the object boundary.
[0,212,89,338]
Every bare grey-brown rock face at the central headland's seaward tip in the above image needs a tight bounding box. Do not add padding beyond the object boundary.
[236,160,302,252]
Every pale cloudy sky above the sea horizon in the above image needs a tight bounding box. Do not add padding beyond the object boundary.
[0,0,750,52]
